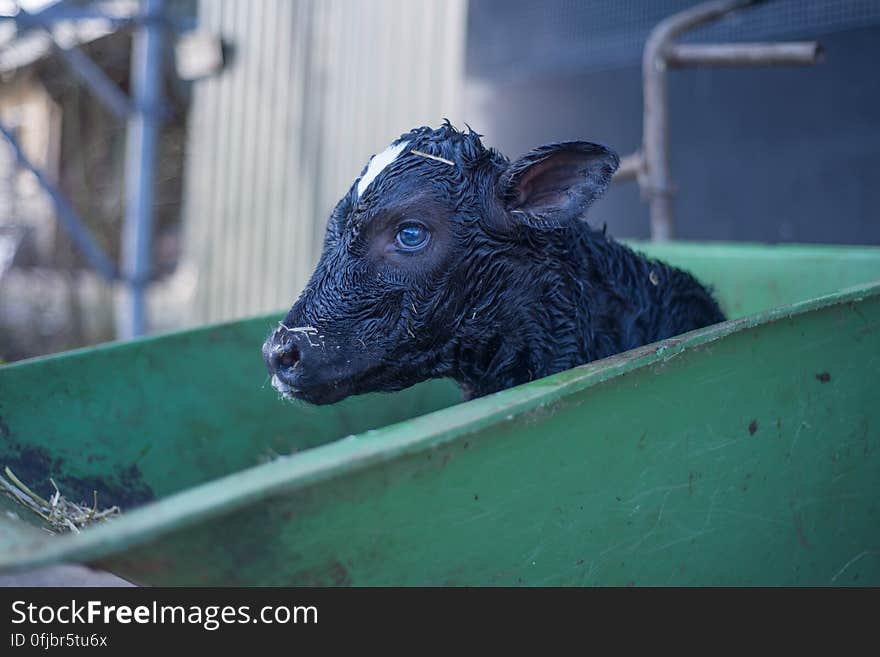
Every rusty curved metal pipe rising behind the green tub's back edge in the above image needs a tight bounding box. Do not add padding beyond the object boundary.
[640,0,754,241]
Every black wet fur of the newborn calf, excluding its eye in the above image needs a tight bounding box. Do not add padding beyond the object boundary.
[263,122,724,403]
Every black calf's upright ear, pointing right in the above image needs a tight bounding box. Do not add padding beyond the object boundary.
[498,141,620,226]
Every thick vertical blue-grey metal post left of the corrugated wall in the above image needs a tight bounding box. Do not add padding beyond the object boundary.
[119,0,164,339]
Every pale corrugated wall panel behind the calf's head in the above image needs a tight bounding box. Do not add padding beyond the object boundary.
[184,0,466,324]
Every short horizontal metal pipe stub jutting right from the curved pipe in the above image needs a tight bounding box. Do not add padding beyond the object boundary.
[666,41,822,68]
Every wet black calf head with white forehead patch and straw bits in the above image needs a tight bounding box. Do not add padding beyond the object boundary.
[263,123,618,404]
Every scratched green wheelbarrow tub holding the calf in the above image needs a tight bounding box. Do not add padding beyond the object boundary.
[0,246,880,585]
